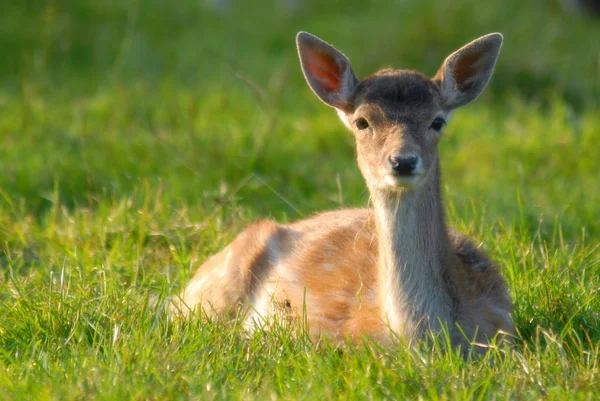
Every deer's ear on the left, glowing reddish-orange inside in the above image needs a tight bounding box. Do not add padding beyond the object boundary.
[296,32,358,111]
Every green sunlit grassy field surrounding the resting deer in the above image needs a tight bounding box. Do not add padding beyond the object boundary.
[0,0,600,400]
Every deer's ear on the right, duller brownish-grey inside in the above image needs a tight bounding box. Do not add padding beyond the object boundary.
[433,33,502,110]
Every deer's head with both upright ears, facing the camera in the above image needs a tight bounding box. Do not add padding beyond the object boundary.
[297,32,502,193]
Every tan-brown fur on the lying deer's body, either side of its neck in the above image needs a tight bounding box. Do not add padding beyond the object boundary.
[174,209,513,344]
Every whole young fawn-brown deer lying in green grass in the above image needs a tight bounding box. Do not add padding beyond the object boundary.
[170,32,514,353]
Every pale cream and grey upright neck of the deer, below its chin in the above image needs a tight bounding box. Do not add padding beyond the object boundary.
[372,161,456,340]
